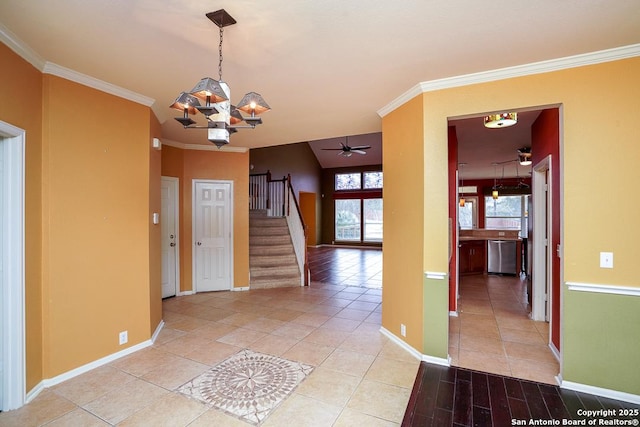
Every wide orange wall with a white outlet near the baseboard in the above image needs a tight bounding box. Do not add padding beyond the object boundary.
[43,75,152,378]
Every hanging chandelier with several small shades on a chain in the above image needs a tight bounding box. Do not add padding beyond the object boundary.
[169,9,271,148]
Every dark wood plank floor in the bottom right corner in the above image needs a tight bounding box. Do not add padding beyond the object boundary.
[402,362,640,427]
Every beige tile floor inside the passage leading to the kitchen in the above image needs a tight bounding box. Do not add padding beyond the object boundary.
[449,275,560,385]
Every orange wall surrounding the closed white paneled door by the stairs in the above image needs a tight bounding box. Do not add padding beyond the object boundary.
[162,146,249,291]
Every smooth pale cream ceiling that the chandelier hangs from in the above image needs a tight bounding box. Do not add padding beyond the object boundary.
[0,0,640,174]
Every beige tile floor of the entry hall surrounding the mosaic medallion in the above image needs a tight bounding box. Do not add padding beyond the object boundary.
[0,265,420,427]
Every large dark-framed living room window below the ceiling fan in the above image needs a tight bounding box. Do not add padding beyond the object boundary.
[334,171,382,242]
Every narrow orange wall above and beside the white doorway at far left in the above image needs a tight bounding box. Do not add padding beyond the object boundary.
[0,43,43,390]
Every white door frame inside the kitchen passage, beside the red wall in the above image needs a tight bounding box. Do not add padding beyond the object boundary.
[531,155,554,324]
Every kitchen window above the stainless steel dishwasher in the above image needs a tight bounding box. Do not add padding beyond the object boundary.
[484,196,529,237]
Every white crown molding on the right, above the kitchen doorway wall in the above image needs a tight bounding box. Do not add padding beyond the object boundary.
[378,43,640,117]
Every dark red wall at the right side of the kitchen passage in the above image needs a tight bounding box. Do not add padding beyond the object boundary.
[531,108,561,350]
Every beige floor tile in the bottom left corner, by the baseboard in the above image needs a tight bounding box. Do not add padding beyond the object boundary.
[0,390,77,427]
